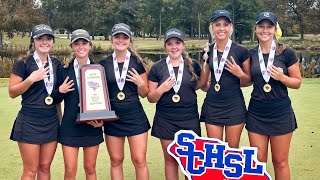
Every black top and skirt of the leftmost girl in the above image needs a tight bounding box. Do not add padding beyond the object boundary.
[10,56,60,144]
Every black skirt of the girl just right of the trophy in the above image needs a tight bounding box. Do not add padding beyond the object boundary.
[104,102,150,137]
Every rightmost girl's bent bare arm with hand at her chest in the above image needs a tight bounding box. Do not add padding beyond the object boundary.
[268,63,302,89]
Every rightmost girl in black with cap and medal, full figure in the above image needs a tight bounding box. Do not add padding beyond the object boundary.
[246,12,301,179]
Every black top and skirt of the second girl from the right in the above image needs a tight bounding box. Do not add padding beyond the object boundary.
[200,42,249,126]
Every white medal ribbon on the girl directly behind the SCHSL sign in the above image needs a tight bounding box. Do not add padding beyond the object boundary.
[166,56,184,93]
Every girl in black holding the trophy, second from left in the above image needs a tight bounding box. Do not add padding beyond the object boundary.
[53,29,103,179]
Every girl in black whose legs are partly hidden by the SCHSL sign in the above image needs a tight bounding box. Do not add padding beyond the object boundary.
[148,28,201,179]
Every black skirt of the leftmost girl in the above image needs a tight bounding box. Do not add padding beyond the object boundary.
[10,106,59,144]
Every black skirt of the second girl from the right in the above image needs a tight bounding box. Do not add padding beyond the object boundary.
[200,91,247,126]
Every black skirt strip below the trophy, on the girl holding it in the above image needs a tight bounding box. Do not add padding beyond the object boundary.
[58,134,104,147]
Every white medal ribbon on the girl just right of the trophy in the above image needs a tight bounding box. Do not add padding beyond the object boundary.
[112,50,131,91]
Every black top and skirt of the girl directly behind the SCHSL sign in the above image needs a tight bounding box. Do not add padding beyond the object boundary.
[148,59,201,140]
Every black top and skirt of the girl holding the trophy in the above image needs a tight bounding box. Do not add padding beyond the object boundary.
[53,59,104,147]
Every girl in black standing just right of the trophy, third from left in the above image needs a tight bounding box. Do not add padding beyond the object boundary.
[99,23,150,180]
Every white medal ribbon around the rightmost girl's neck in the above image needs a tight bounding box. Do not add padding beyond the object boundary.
[258,41,276,83]
